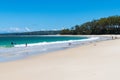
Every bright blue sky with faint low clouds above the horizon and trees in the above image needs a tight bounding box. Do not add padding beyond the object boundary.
[0,0,120,33]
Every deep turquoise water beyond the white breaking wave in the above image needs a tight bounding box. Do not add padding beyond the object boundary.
[0,36,87,47]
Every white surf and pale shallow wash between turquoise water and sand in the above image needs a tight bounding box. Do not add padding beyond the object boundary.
[0,35,111,62]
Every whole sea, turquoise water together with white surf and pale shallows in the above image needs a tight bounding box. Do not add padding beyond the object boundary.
[0,35,101,62]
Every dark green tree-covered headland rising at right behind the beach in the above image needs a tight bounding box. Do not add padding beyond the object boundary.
[60,16,120,35]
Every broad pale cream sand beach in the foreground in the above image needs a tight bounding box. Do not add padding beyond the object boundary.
[0,35,120,80]
